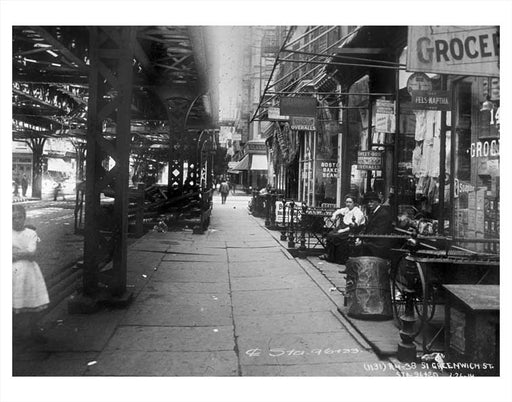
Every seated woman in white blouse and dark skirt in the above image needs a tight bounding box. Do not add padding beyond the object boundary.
[320,194,365,264]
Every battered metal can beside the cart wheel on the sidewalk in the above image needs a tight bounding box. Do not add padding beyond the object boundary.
[346,257,393,320]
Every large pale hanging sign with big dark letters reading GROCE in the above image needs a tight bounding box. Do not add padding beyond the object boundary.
[407,25,500,77]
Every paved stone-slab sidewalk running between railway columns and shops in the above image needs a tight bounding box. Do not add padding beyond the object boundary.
[13,196,416,376]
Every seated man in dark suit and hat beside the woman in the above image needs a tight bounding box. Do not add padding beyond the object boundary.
[356,191,393,259]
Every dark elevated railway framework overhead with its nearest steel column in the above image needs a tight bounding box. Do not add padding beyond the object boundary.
[12,26,218,299]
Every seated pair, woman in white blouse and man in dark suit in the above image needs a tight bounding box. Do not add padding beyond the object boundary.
[320,192,394,264]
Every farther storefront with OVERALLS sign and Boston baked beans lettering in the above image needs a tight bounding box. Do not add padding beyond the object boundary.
[267,76,339,207]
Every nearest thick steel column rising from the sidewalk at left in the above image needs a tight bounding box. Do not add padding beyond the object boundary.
[83,27,135,296]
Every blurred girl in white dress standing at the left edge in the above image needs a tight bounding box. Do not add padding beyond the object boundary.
[12,204,50,343]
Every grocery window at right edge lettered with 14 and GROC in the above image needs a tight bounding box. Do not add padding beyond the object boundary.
[453,77,500,253]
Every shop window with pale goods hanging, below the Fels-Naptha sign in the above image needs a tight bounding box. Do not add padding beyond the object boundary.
[395,74,452,235]
